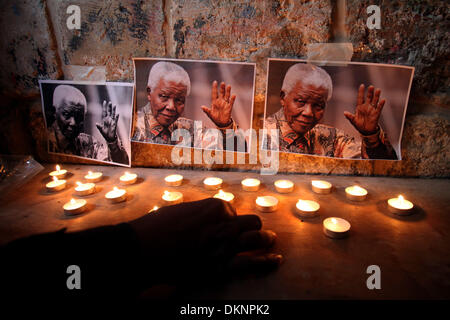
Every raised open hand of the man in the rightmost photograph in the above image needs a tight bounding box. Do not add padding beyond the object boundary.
[344,84,386,136]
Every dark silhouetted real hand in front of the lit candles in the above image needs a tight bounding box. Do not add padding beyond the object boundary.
[130,198,281,283]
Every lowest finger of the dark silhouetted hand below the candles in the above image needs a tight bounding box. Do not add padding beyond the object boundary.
[228,253,283,273]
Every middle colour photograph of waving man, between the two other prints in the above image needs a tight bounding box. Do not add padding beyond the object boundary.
[132,58,255,152]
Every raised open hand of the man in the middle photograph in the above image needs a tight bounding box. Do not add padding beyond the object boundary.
[201,81,236,127]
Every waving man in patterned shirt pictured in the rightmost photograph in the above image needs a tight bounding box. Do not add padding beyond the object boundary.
[265,63,397,159]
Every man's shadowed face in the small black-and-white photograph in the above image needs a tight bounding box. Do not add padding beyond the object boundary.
[56,100,85,140]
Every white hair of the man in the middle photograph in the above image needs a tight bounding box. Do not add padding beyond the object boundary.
[147,61,191,95]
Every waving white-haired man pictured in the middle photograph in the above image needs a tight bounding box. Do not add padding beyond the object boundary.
[133,61,243,149]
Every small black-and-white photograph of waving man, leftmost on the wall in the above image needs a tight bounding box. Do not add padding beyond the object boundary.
[41,82,132,165]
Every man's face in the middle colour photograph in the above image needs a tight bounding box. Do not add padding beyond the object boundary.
[147,79,187,127]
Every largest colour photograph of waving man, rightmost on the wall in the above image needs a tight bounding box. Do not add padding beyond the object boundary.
[262,59,414,160]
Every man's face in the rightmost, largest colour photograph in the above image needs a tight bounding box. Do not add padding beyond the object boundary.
[281,81,328,134]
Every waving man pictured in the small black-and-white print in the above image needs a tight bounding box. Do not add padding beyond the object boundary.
[47,85,129,164]
